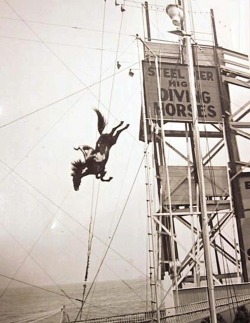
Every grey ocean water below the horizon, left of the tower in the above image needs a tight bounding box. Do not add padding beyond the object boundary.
[0,280,150,323]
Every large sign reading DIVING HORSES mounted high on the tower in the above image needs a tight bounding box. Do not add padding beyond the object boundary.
[143,61,222,123]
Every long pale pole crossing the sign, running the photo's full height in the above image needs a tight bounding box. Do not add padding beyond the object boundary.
[183,1,217,323]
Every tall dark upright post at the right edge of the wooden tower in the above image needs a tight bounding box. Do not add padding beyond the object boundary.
[210,9,248,282]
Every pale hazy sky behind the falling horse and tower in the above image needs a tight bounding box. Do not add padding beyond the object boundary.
[0,0,250,304]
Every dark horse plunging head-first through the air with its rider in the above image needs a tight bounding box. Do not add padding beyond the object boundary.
[71,109,129,191]
